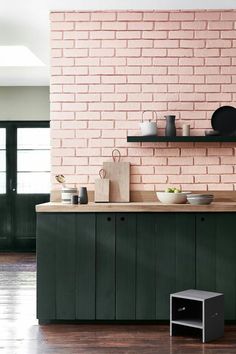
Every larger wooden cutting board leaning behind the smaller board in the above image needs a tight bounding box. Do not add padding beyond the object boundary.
[103,149,130,203]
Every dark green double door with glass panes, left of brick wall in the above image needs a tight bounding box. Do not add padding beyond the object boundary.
[0,122,50,250]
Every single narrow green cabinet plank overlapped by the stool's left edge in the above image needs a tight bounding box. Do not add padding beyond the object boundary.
[156,213,176,320]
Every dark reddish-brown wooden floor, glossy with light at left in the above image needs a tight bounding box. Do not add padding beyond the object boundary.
[0,253,236,354]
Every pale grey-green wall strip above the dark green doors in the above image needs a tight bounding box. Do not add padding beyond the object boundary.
[0,86,50,120]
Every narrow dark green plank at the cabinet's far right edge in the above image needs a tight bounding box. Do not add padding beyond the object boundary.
[215,213,236,320]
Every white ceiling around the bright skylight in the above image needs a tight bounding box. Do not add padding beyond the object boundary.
[0,0,236,86]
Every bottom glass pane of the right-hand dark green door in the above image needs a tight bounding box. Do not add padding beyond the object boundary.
[17,172,50,194]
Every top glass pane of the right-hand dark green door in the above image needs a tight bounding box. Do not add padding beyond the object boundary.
[17,128,50,150]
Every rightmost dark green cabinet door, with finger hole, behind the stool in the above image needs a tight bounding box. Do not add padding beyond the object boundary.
[196,213,236,320]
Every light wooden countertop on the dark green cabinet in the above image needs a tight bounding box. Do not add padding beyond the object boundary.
[36,201,236,213]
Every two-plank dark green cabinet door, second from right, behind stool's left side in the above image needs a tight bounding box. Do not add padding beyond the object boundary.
[156,213,195,320]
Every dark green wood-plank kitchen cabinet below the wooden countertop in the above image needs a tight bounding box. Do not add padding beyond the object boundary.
[37,213,236,321]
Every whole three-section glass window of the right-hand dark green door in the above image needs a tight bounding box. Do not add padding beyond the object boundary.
[17,128,50,194]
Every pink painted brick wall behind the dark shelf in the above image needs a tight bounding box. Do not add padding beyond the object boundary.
[51,10,236,190]
